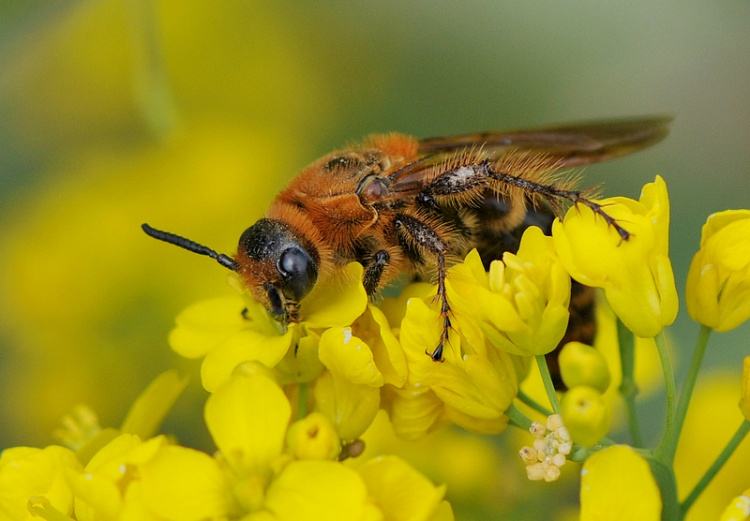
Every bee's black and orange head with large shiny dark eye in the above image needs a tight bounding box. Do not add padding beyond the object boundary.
[235,219,318,321]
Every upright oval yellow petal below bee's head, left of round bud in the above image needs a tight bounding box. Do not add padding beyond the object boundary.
[205,373,291,474]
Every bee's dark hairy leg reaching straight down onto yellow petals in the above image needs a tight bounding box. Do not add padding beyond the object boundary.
[394,214,451,362]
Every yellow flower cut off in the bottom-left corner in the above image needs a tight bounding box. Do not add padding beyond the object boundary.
[0,445,80,521]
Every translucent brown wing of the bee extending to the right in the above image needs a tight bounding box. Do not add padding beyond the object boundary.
[389,116,672,194]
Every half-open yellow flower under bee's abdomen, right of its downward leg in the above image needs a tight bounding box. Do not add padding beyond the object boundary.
[448,226,570,356]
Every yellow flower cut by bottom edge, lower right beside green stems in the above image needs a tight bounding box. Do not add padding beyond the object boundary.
[581,445,661,521]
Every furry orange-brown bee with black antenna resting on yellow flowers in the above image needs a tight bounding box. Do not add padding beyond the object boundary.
[142,117,670,361]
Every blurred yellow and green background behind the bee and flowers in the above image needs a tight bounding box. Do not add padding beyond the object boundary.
[0,0,750,515]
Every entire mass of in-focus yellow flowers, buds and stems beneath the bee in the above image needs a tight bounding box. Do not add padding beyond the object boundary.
[0,177,750,521]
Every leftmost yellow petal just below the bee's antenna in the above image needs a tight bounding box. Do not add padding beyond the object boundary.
[169,296,247,358]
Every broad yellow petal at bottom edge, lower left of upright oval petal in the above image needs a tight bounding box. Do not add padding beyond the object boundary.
[140,446,232,521]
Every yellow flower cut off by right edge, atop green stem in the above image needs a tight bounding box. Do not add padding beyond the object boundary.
[686,210,750,331]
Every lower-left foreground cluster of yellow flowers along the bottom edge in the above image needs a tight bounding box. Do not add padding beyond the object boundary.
[0,368,453,521]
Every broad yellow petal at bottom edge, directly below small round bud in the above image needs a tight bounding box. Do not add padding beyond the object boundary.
[265,461,383,521]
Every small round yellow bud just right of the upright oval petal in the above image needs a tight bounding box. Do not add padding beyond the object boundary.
[286,412,341,460]
